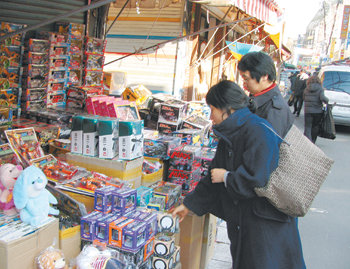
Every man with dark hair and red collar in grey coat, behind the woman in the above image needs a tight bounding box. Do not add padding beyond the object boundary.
[238,52,294,137]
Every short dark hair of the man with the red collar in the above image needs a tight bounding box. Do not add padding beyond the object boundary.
[238,52,276,82]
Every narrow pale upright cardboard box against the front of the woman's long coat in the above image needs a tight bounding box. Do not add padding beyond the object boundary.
[199,214,217,269]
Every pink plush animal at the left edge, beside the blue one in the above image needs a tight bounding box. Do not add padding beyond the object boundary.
[0,163,23,215]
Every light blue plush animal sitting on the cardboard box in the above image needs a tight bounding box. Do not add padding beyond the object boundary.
[13,165,59,227]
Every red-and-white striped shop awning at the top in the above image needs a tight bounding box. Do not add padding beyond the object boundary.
[190,0,283,24]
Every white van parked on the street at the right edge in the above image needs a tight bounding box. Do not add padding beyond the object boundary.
[318,65,350,126]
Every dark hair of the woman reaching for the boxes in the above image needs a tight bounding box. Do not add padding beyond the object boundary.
[205,80,249,115]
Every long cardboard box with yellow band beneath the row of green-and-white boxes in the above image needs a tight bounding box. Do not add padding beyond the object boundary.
[66,153,143,188]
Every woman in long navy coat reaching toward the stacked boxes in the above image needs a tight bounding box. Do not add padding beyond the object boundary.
[173,81,305,269]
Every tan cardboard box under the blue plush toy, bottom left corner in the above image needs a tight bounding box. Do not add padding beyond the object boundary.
[0,219,59,269]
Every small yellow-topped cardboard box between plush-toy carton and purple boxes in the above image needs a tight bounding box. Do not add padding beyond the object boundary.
[59,225,81,264]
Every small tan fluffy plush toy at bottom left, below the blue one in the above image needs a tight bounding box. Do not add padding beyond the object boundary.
[36,246,68,269]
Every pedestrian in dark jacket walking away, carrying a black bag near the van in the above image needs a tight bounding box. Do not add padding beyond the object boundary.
[303,76,328,143]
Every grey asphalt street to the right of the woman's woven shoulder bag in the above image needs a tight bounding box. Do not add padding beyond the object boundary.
[295,112,350,269]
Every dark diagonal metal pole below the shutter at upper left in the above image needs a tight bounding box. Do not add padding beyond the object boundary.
[0,0,115,41]
